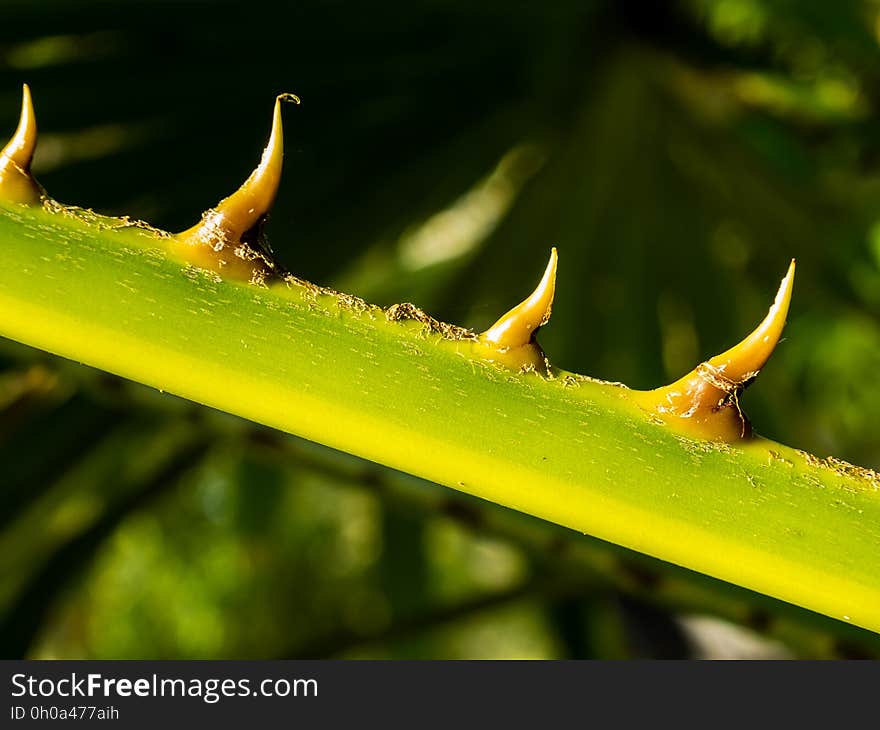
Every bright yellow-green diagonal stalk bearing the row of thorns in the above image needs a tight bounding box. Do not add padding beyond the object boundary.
[0,207,880,631]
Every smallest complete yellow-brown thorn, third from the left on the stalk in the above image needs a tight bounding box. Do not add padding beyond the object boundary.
[478,248,558,372]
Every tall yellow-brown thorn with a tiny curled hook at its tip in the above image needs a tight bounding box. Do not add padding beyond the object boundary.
[172,94,300,282]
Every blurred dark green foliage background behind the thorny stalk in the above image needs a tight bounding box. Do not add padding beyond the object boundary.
[0,0,880,658]
